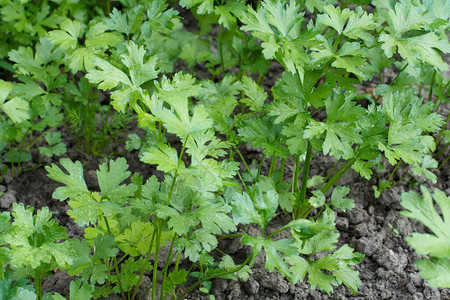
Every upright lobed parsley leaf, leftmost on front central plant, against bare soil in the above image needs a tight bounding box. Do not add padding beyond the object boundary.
[45,158,88,201]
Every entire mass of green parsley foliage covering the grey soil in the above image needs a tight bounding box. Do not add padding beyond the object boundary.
[0,0,450,300]
